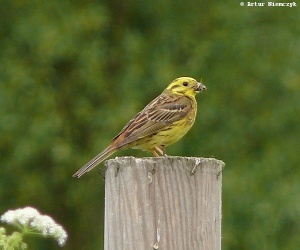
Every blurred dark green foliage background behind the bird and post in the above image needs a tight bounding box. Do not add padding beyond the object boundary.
[0,0,300,250]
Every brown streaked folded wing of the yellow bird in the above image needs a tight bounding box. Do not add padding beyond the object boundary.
[113,93,192,147]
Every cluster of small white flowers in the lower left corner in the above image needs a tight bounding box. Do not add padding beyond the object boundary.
[1,207,68,246]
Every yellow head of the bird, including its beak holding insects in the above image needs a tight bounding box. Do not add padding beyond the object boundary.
[165,77,206,97]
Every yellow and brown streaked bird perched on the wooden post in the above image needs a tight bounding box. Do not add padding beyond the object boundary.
[73,77,206,178]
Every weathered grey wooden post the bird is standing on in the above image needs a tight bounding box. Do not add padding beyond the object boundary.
[104,157,224,250]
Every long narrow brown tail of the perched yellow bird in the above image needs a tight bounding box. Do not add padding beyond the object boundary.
[72,145,117,178]
